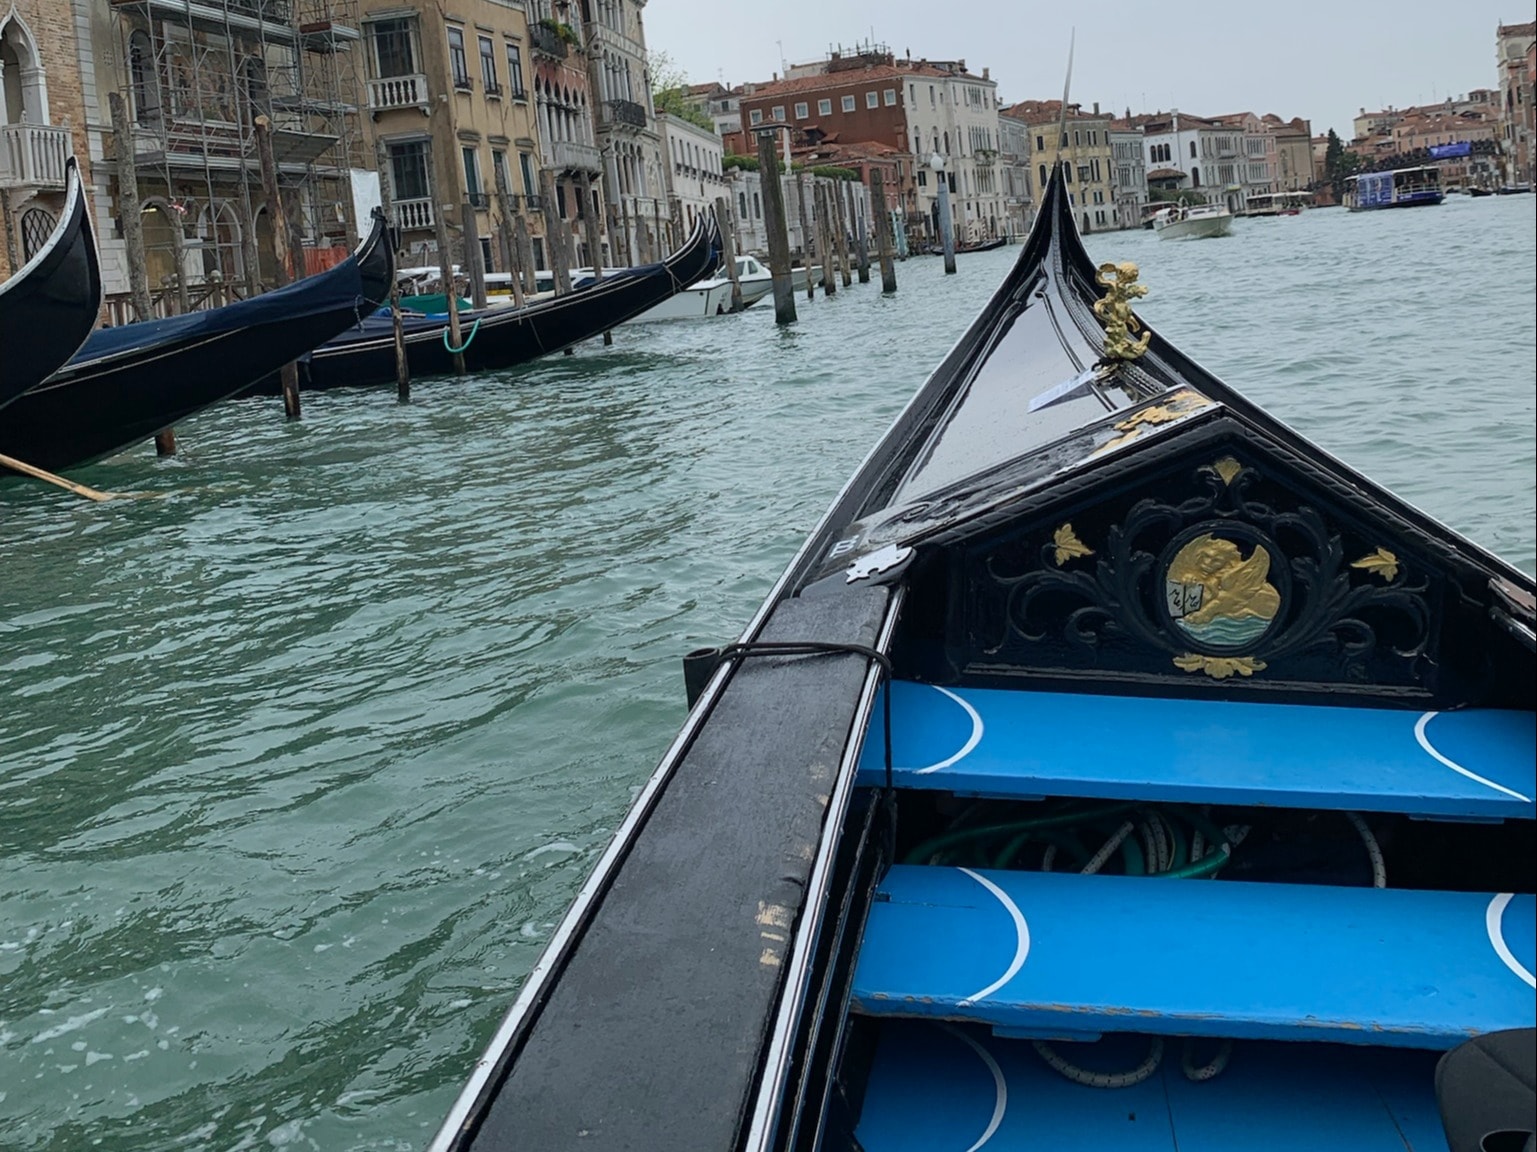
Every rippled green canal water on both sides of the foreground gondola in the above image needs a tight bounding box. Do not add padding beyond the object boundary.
[0,197,1537,1152]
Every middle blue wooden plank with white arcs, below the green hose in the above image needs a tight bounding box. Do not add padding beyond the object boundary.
[853,865,1537,1049]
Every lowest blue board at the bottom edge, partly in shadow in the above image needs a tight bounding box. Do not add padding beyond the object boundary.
[856,1021,1446,1152]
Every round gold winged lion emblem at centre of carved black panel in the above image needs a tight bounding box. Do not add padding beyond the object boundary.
[1164,531,1280,654]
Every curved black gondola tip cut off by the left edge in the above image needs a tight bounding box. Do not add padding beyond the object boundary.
[0,157,101,414]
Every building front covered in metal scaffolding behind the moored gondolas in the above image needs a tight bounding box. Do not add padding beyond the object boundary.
[72,0,366,321]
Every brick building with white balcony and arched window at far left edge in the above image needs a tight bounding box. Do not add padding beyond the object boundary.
[0,0,89,280]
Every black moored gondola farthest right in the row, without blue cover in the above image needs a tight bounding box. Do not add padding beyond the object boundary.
[254,217,721,392]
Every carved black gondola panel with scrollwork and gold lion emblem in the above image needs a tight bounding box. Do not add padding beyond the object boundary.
[950,447,1442,691]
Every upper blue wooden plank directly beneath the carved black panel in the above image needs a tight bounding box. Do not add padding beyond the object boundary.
[861,680,1537,820]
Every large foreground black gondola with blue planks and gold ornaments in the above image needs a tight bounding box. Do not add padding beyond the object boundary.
[432,164,1537,1152]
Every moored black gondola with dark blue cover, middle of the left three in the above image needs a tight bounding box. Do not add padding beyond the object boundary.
[0,211,395,472]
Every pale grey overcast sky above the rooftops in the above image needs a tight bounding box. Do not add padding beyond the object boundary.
[646,0,1532,138]
